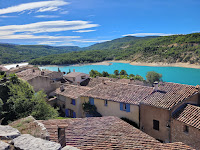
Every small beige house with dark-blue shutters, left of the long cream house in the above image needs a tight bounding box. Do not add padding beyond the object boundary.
[55,84,90,118]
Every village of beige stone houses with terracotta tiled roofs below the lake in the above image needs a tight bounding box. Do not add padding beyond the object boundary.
[0,65,200,150]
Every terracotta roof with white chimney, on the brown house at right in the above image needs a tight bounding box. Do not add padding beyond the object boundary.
[142,82,198,109]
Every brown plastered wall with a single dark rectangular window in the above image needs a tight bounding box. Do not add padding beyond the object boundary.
[140,104,170,142]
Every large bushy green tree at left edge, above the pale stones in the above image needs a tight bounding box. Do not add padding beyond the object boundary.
[0,74,58,124]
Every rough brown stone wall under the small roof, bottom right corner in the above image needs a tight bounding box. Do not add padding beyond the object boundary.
[171,119,200,149]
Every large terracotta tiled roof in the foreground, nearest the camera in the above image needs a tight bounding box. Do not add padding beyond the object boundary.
[40,116,191,149]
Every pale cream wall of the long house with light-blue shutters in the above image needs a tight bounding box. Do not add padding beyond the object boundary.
[81,97,139,126]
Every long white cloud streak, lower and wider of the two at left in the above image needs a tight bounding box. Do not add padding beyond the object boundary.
[0,20,99,34]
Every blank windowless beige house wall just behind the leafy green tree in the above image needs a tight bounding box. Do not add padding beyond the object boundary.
[28,76,61,95]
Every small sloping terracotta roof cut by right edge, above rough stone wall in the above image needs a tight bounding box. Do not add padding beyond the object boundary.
[173,104,200,129]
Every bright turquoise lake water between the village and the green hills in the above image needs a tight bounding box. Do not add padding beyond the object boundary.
[40,62,200,85]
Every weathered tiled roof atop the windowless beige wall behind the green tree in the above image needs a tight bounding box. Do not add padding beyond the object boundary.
[16,69,53,81]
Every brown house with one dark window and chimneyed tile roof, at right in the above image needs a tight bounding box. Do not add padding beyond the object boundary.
[140,83,199,142]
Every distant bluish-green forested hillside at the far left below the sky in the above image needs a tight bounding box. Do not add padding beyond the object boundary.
[0,44,80,64]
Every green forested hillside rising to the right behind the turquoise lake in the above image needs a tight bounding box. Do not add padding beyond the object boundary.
[30,33,200,65]
